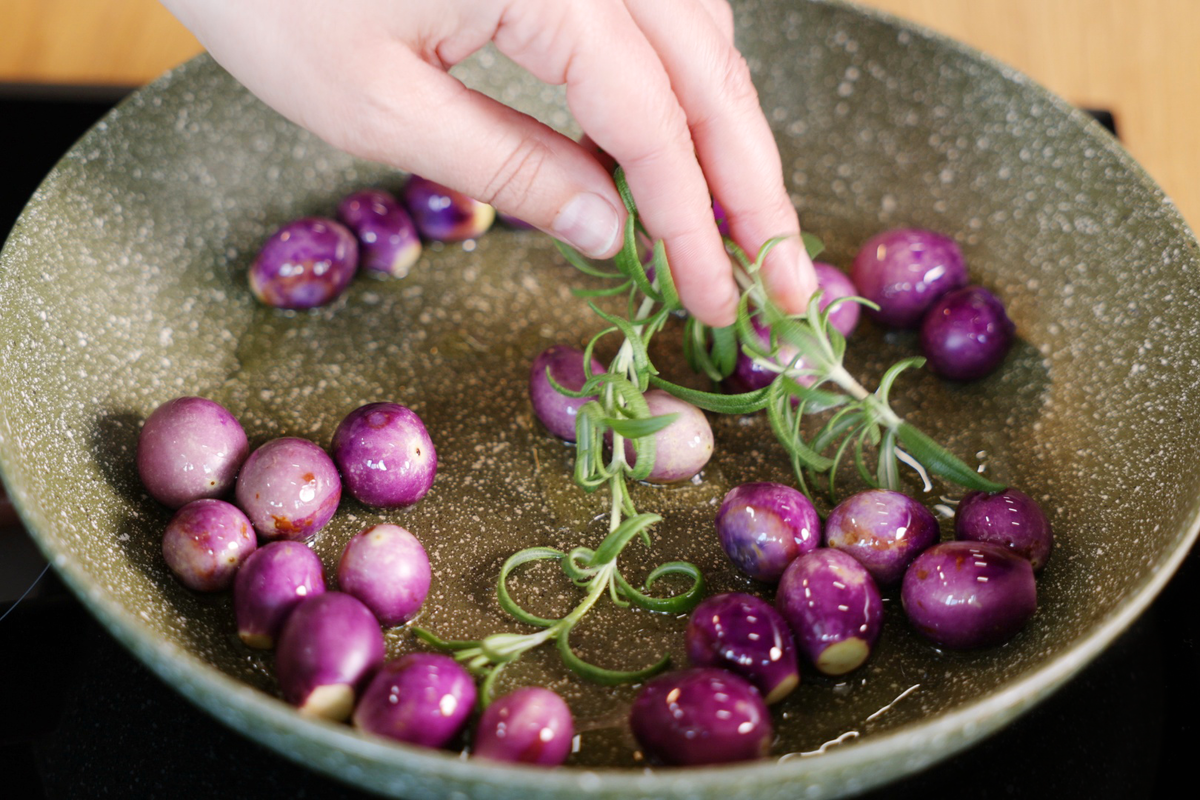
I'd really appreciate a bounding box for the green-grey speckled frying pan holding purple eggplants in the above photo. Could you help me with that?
[0,0,1200,800]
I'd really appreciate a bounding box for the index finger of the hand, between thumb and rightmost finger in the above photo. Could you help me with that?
[496,0,737,325]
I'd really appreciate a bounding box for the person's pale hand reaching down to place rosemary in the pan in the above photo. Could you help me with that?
[163,0,816,325]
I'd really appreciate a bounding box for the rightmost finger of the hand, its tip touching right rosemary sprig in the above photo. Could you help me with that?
[626,0,816,313]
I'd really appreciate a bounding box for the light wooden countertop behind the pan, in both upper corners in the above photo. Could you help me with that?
[0,0,1200,229]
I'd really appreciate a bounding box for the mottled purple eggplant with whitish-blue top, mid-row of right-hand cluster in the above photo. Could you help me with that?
[824,489,941,587]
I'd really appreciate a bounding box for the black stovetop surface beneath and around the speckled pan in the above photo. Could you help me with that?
[0,88,1200,800]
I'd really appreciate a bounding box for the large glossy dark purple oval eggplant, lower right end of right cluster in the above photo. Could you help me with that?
[900,541,1038,650]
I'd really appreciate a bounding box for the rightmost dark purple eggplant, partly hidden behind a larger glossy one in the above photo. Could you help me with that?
[954,488,1054,572]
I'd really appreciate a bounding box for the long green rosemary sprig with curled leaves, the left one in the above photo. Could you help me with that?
[414,170,704,705]
